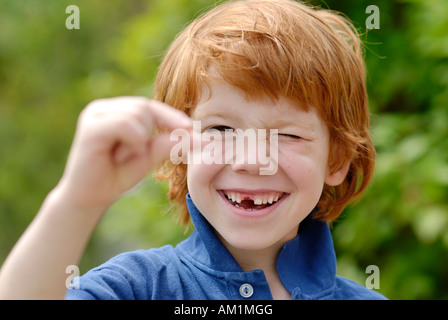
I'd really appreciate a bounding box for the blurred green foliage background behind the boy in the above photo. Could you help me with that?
[0,0,448,299]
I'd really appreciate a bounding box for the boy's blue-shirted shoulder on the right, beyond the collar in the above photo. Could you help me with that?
[334,276,387,300]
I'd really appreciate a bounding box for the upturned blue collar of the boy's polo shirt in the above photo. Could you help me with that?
[186,194,336,297]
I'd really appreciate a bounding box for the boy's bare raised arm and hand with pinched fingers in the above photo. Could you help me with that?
[0,97,191,299]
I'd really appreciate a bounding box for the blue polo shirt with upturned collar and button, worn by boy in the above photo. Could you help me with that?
[66,195,384,300]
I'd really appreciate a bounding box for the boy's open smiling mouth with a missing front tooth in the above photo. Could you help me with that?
[221,190,285,211]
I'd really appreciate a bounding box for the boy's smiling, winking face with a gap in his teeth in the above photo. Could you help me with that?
[187,77,345,250]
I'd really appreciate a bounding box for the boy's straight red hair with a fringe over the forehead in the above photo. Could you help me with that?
[154,0,375,223]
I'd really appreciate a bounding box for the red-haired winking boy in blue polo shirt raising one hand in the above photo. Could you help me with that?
[0,0,383,299]
